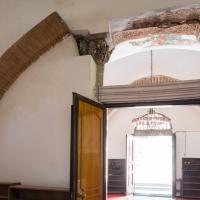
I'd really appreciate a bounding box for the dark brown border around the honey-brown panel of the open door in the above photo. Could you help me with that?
[70,92,107,200]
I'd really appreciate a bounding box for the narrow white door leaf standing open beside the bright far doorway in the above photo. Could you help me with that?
[126,135,134,194]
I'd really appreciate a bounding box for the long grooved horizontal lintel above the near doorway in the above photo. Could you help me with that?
[98,80,200,105]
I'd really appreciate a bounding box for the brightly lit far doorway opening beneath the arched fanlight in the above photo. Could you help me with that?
[133,136,173,197]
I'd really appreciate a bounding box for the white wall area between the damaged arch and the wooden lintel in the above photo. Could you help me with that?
[104,46,200,86]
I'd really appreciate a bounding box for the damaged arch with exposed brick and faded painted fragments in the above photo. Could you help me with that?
[110,4,200,46]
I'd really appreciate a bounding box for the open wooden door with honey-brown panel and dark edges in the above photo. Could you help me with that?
[70,93,106,200]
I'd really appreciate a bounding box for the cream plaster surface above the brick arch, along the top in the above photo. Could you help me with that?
[0,0,200,55]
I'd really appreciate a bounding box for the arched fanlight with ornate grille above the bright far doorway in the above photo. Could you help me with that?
[132,108,172,135]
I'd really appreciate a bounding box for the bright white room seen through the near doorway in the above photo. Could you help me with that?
[107,105,200,200]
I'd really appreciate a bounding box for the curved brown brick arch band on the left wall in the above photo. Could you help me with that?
[0,12,70,99]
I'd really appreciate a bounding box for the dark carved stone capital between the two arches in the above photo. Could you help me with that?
[75,33,111,65]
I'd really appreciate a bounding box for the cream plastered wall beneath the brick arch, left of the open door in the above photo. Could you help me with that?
[0,37,96,187]
